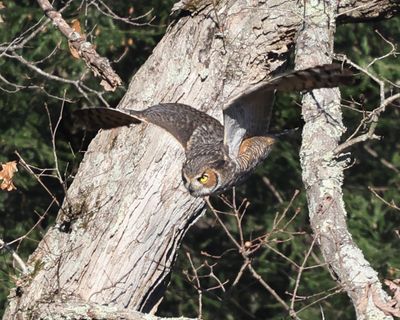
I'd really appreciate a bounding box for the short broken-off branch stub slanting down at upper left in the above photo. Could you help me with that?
[37,0,122,91]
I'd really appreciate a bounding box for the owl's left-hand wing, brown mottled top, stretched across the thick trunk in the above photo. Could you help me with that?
[75,103,223,150]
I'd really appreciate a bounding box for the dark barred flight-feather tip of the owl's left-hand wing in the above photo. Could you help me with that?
[73,108,142,131]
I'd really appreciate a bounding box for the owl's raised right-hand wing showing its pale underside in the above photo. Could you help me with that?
[224,64,353,158]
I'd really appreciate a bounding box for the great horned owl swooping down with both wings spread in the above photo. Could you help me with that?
[76,64,353,197]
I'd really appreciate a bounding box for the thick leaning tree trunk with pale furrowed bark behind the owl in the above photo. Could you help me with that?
[3,0,400,319]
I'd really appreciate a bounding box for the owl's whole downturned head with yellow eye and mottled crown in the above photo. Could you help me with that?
[182,159,226,197]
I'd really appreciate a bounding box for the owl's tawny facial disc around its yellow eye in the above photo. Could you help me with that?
[182,169,219,197]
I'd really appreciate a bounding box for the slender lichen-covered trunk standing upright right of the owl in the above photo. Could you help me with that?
[296,0,392,320]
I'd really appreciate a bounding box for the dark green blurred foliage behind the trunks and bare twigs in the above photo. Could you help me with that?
[0,0,400,319]
